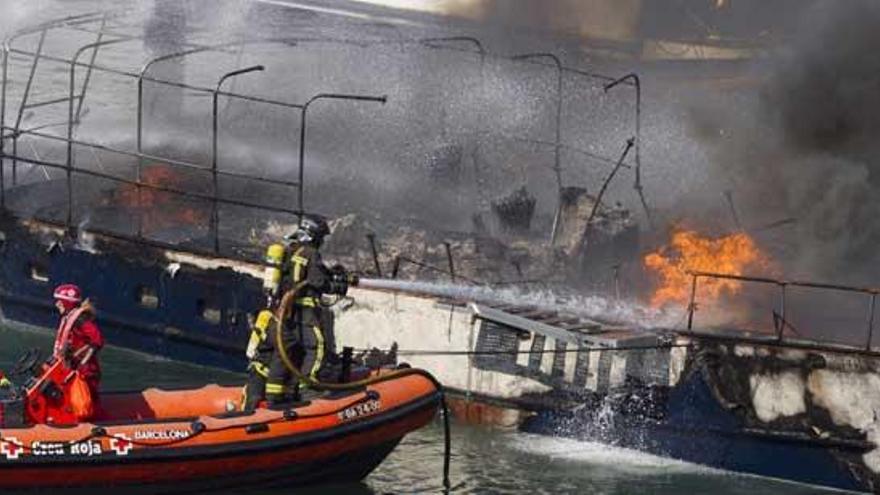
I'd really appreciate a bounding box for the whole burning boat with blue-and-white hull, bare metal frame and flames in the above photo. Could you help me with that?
[0,3,880,491]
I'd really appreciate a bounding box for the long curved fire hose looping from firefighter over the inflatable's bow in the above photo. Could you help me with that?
[274,282,452,492]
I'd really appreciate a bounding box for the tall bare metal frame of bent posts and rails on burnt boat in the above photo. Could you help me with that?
[0,13,640,260]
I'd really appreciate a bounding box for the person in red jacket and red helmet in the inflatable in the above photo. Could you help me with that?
[53,284,104,404]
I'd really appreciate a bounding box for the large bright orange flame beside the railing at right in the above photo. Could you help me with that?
[644,228,771,307]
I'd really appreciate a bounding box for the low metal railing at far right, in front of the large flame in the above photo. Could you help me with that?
[687,272,880,352]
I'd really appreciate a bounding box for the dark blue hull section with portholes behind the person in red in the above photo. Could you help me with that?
[0,217,254,371]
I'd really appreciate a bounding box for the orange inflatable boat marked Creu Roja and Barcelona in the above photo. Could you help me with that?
[0,369,442,495]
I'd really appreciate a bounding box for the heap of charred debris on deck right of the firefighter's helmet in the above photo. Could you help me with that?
[308,184,639,289]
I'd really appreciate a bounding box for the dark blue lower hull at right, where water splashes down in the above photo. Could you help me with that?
[522,373,876,491]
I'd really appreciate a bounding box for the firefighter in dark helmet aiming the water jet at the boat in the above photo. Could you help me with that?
[266,215,357,405]
